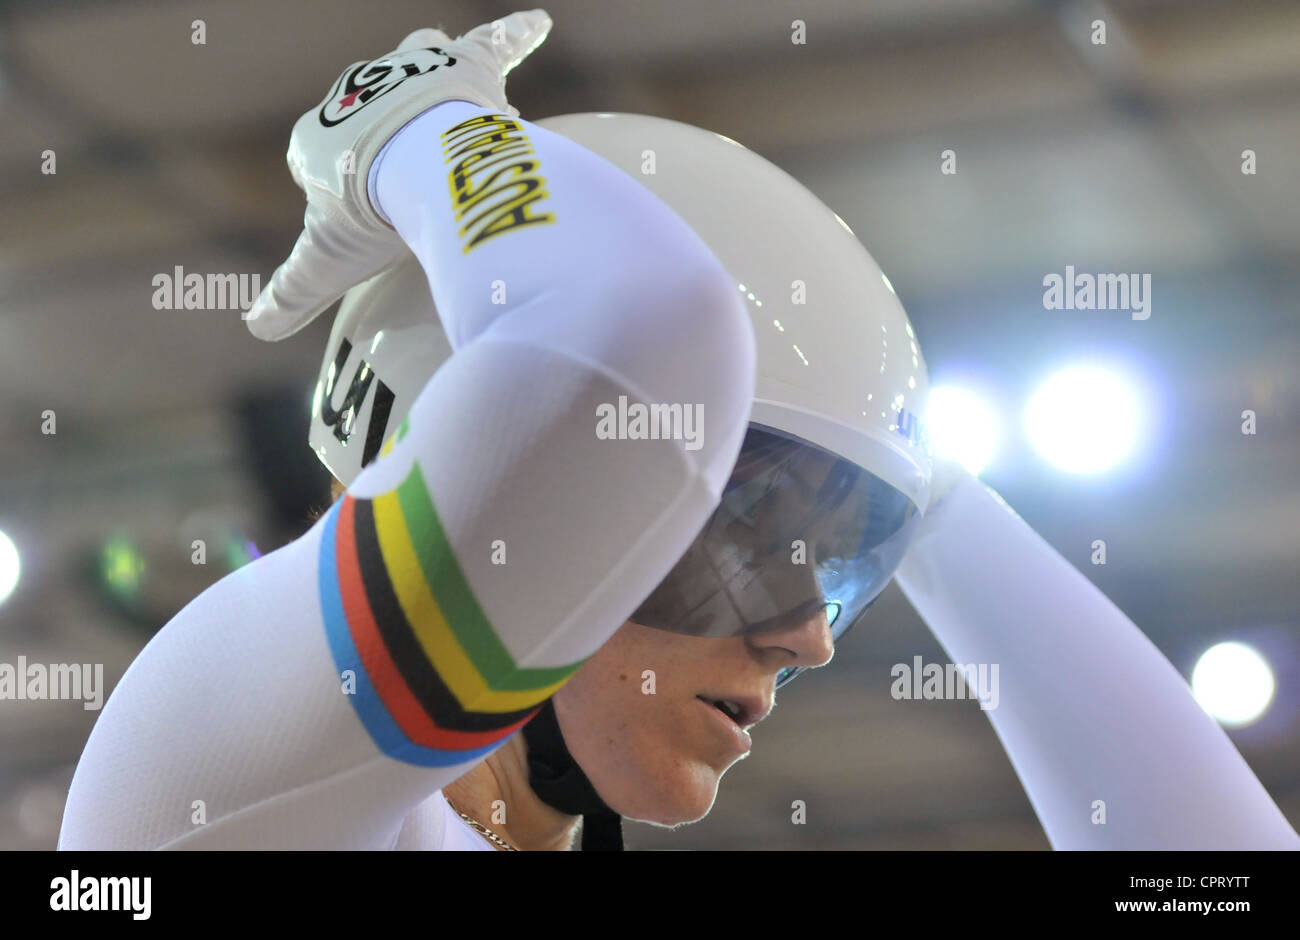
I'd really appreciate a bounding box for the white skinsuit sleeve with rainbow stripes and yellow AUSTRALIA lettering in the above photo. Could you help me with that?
[60,101,754,849]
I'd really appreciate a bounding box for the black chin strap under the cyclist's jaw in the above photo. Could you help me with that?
[524,701,623,852]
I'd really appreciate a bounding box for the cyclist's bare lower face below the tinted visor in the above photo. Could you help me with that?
[554,611,833,826]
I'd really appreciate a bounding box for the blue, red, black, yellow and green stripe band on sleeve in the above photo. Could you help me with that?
[319,460,581,767]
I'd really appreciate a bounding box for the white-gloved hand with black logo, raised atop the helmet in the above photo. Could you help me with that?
[244,9,551,339]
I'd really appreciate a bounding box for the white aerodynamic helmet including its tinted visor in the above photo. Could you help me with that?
[309,113,931,681]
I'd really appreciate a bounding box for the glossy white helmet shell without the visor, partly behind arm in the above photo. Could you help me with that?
[309,113,931,511]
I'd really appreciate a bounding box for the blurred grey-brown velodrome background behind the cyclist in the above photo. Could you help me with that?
[0,0,1300,849]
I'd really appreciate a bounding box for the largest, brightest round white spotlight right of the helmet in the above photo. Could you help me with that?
[1024,365,1141,473]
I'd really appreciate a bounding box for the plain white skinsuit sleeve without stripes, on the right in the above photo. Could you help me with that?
[897,475,1300,850]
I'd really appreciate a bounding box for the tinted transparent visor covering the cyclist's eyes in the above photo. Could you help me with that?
[632,424,920,685]
